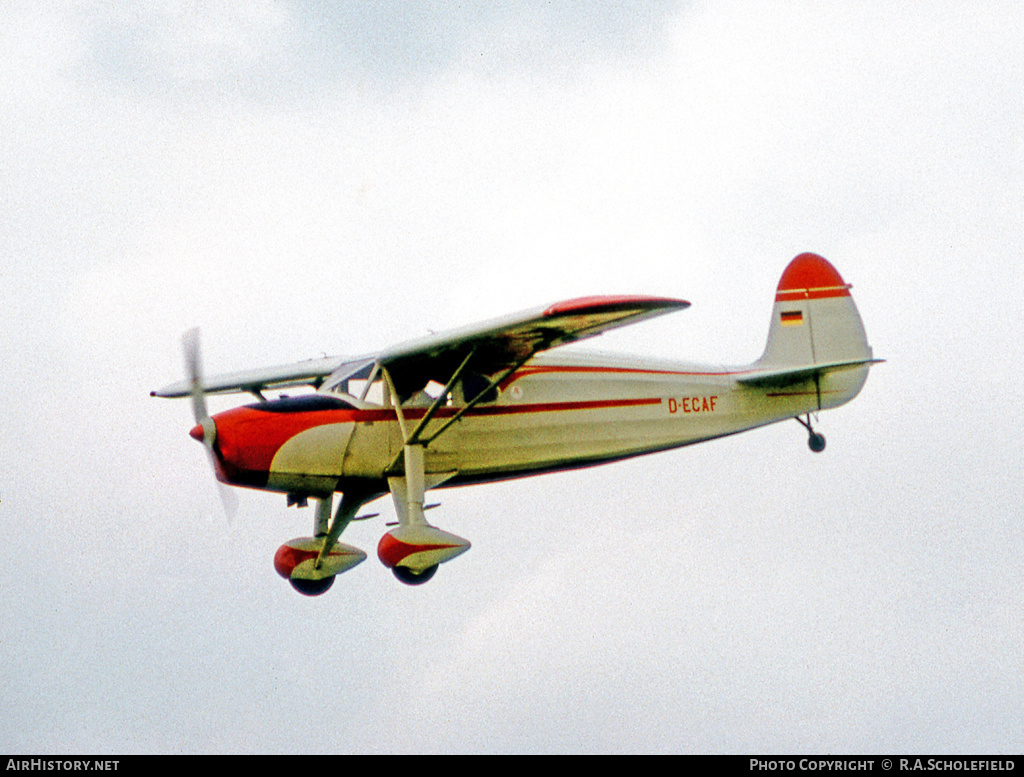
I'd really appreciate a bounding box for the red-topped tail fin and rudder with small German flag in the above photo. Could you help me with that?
[740,254,880,409]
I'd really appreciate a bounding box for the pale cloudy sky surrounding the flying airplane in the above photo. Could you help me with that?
[0,0,1024,753]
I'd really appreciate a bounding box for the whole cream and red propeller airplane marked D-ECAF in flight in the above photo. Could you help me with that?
[151,253,882,596]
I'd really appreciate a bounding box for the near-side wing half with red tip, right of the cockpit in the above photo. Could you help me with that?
[368,296,690,397]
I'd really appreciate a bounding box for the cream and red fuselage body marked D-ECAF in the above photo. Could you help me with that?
[213,350,867,494]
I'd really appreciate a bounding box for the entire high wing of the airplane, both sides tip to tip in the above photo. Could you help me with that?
[151,296,690,399]
